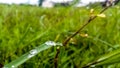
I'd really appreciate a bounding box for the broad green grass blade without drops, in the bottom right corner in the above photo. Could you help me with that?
[86,46,120,67]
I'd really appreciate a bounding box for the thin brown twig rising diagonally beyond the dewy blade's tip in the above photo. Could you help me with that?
[54,5,111,68]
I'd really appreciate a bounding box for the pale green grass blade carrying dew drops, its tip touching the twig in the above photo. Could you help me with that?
[3,41,62,68]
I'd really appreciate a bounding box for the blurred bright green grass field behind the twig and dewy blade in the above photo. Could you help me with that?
[0,5,120,68]
